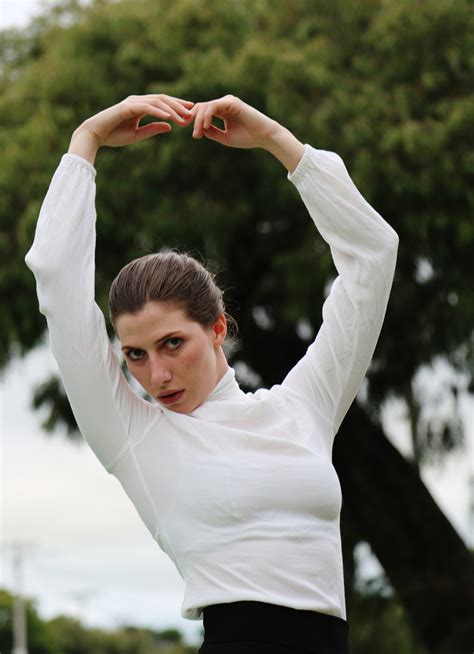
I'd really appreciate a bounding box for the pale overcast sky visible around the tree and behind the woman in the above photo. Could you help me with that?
[0,0,474,640]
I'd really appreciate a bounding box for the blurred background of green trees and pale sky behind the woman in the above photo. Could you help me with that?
[0,0,474,654]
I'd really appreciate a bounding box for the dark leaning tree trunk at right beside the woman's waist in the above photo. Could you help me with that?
[334,403,474,654]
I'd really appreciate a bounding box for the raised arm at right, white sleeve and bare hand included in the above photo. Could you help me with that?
[191,96,398,436]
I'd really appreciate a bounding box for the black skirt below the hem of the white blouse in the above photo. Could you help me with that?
[198,602,349,654]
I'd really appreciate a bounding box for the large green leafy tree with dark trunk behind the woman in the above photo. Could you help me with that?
[0,0,474,654]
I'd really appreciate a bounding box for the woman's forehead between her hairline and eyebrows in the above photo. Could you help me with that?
[115,302,200,344]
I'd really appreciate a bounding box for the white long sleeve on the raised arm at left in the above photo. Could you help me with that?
[25,154,157,471]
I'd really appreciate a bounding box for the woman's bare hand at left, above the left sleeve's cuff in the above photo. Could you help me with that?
[69,94,194,164]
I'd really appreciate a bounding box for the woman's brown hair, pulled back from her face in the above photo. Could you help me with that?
[109,250,236,340]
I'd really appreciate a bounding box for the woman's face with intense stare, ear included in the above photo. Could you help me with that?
[115,302,228,413]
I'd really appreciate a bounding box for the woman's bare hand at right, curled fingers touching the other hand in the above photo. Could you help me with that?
[191,95,282,148]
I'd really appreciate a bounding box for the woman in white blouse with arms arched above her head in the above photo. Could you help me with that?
[26,95,398,654]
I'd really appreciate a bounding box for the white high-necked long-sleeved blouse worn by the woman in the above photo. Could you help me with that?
[26,145,398,619]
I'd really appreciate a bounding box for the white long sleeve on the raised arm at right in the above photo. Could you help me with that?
[283,145,398,436]
